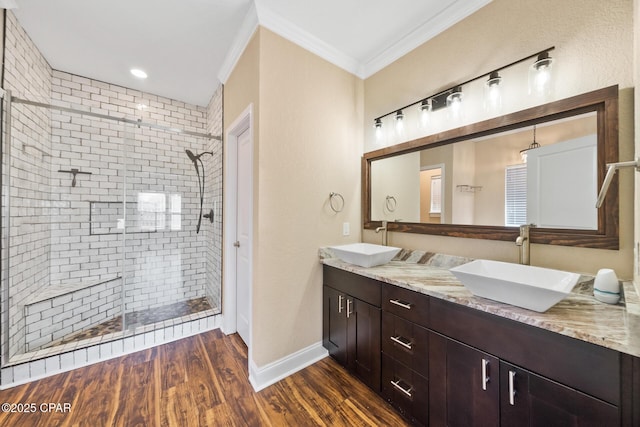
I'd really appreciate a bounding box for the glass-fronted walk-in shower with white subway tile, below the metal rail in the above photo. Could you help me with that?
[2,93,221,366]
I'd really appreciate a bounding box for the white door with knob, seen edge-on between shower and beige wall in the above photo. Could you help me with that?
[235,129,253,345]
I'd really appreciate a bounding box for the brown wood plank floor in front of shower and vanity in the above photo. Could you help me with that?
[0,330,407,427]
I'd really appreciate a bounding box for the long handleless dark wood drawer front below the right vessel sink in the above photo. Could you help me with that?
[429,299,620,405]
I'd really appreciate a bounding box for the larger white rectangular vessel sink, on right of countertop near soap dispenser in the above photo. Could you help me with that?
[450,260,580,312]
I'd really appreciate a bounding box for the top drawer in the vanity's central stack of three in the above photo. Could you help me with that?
[382,284,429,327]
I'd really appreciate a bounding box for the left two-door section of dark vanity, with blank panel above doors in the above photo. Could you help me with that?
[322,266,381,392]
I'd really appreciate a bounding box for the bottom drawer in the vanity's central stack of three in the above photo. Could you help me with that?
[381,354,429,425]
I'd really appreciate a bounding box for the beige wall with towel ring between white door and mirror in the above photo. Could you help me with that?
[224,28,363,367]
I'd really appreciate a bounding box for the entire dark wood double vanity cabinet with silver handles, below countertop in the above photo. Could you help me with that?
[323,265,640,427]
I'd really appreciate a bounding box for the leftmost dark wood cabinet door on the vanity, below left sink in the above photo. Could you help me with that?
[322,286,347,366]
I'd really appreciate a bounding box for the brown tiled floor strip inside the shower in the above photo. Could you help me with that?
[46,297,212,348]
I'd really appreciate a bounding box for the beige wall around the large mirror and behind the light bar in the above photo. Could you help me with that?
[363,0,634,278]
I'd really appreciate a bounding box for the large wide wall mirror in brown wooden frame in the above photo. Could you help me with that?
[362,86,619,249]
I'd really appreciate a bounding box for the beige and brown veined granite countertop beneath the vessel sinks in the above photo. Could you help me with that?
[319,248,640,357]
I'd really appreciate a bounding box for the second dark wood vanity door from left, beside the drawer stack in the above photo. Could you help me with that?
[347,296,381,391]
